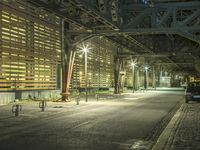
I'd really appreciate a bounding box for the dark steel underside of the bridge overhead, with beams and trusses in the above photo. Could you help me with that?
[29,0,200,73]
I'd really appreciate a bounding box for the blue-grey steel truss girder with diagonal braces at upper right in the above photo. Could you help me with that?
[121,2,200,43]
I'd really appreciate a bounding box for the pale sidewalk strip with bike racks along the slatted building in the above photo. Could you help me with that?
[0,95,123,119]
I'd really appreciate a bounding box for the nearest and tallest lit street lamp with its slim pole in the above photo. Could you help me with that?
[81,45,91,102]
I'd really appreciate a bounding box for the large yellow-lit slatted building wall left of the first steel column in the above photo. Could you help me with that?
[0,0,61,92]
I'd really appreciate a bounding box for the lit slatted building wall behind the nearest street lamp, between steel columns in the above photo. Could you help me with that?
[72,37,117,89]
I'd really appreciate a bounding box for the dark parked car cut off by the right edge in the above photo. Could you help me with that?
[185,82,200,103]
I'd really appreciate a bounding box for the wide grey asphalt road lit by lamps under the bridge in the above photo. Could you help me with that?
[0,91,183,150]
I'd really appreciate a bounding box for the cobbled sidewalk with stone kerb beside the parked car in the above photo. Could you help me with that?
[153,102,200,150]
